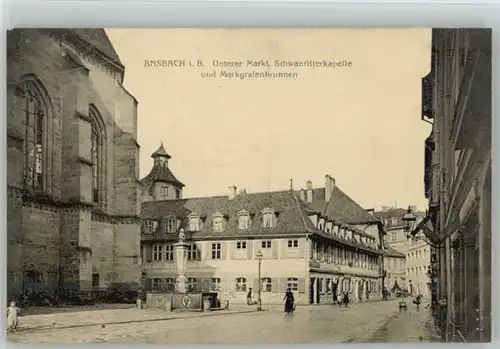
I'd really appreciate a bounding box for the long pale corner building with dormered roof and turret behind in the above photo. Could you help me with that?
[142,147,383,303]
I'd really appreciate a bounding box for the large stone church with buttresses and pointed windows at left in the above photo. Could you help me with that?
[7,29,141,298]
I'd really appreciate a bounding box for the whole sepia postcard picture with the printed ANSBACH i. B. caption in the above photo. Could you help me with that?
[5,28,492,344]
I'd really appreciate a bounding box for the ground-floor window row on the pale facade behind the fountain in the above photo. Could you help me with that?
[146,277,302,292]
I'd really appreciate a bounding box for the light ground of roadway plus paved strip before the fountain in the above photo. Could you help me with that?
[8,300,426,345]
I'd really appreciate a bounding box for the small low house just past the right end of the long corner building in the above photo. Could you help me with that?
[384,245,407,293]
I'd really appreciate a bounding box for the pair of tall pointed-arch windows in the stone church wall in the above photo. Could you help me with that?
[16,80,106,203]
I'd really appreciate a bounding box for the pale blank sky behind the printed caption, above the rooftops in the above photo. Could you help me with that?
[107,29,431,209]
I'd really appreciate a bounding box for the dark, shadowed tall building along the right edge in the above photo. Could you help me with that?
[416,29,492,342]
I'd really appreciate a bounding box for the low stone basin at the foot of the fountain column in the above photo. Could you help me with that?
[146,292,221,311]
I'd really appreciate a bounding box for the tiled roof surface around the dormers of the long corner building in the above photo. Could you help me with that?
[141,190,379,253]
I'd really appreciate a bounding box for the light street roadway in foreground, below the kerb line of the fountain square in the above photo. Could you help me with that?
[9,300,425,344]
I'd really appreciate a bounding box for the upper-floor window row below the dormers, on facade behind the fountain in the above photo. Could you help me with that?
[146,240,299,261]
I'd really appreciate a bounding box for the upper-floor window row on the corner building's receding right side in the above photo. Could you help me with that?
[309,241,379,270]
